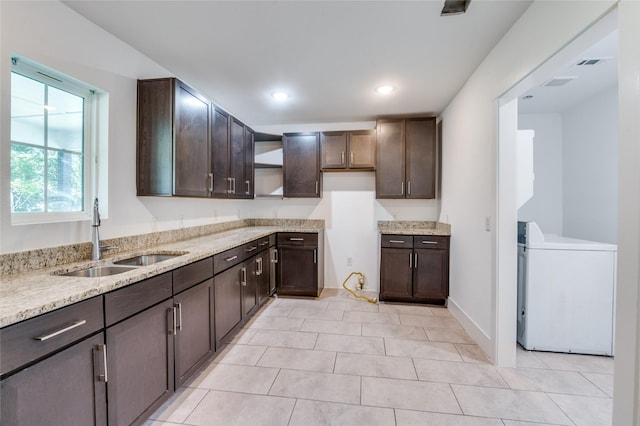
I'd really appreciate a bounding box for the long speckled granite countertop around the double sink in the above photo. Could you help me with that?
[0,221,324,328]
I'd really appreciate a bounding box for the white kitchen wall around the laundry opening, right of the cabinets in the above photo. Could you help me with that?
[441,1,614,362]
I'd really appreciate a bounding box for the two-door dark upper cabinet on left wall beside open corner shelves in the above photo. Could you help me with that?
[211,108,254,198]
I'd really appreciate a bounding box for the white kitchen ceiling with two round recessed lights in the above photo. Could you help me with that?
[64,0,531,126]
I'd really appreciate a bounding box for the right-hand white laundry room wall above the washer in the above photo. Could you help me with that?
[564,87,619,244]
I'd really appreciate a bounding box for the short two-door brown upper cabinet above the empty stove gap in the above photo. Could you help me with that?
[320,130,376,171]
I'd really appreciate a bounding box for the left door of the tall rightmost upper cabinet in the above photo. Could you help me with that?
[376,120,405,198]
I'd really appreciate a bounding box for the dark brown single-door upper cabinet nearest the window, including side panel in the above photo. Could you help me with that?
[136,78,211,197]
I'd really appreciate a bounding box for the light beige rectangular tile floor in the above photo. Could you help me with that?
[145,289,613,426]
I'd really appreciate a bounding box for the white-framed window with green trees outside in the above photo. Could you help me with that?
[10,58,96,223]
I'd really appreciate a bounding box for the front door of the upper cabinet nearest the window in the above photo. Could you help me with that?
[173,81,210,197]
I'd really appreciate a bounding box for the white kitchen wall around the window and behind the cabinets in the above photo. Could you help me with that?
[0,1,439,290]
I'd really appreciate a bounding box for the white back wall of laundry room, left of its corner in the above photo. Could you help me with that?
[518,113,562,235]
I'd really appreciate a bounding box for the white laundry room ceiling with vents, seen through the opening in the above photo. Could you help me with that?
[518,31,618,114]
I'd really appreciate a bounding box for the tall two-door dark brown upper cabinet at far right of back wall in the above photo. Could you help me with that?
[376,117,436,199]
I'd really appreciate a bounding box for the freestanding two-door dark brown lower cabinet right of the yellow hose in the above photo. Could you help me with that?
[380,235,449,304]
